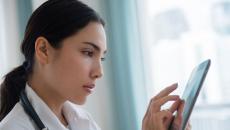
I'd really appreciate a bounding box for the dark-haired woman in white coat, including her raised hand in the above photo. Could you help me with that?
[0,0,190,130]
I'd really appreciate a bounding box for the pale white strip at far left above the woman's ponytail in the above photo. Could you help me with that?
[0,0,22,77]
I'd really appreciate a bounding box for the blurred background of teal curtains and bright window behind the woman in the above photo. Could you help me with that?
[0,0,230,130]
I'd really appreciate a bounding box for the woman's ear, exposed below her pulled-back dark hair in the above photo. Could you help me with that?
[35,37,51,65]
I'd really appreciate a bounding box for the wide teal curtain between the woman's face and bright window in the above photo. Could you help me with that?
[105,0,147,130]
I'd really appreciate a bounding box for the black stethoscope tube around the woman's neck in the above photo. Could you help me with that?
[20,90,48,130]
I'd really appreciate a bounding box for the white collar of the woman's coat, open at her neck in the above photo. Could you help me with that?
[25,84,100,130]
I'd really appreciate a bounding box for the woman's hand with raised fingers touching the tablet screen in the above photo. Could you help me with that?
[142,84,181,130]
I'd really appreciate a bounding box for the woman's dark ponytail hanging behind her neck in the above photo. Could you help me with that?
[0,65,27,121]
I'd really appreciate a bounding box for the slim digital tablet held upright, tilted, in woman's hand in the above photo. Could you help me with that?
[170,59,211,130]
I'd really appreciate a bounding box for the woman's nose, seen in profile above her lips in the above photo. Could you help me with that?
[91,62,103,79]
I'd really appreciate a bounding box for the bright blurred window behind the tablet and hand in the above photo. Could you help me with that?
[138,0,230,130]
